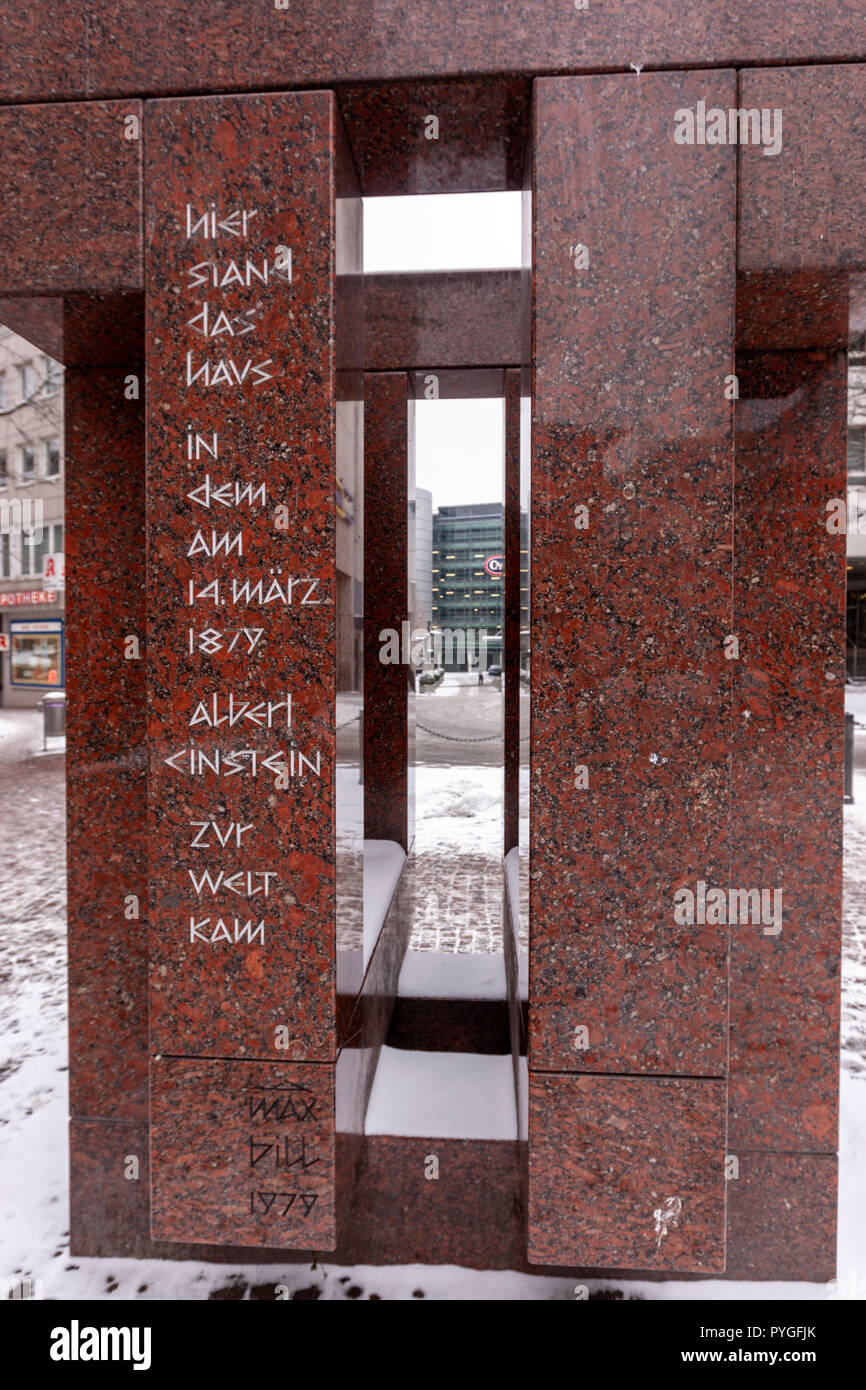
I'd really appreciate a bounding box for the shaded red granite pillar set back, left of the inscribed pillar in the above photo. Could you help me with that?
[61,299,147,1254]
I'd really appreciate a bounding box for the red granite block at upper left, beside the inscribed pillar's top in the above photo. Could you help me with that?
[0,100,143,295]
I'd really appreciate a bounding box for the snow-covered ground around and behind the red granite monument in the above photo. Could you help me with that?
[0,706,866,1301]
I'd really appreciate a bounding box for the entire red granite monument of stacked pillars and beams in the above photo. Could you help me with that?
[0,0,866,1280]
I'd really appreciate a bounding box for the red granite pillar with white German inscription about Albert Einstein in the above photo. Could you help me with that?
[145,92,361,1250]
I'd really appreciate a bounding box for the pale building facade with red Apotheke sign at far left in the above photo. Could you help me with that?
[0,325,65,709]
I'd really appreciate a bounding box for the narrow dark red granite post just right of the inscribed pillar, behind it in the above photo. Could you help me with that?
[364,373,416,851]
